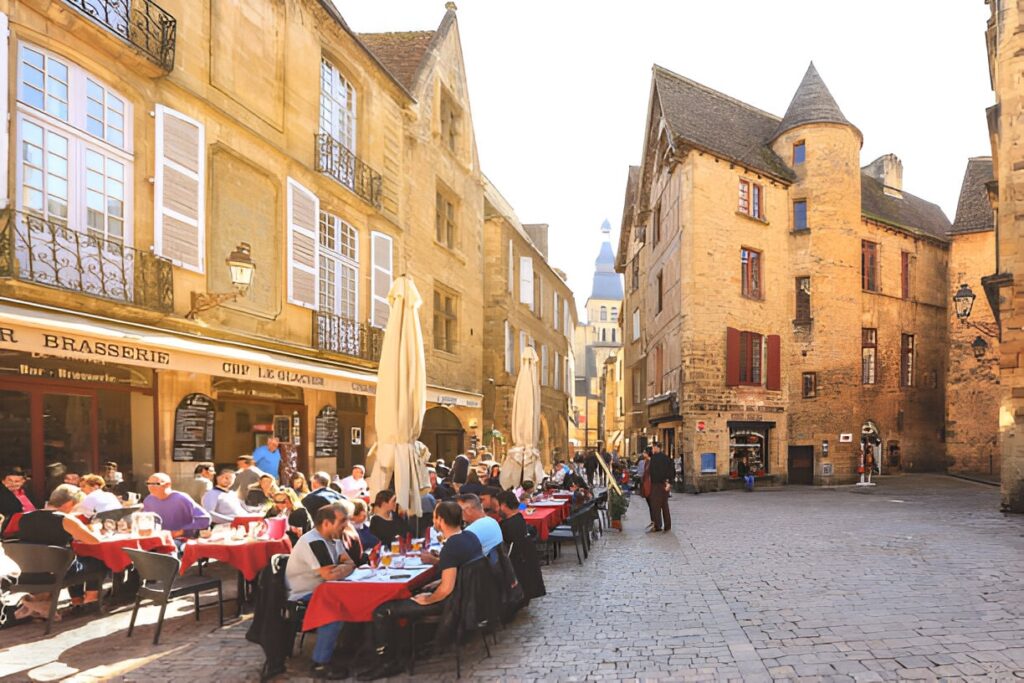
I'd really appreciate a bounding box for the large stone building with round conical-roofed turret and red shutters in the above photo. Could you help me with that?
[620,65,949,489]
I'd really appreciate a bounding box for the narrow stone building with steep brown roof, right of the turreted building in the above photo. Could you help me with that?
[946,157,1000,477]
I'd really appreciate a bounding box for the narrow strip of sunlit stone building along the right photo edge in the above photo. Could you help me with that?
[976,0,1024,512]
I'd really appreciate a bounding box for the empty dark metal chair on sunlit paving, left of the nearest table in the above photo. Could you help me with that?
[124,548,224,645]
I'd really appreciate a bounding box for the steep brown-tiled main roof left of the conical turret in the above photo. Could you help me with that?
[654,65,796,181]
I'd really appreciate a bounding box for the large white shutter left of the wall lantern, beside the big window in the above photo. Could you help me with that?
[154,104,206,272]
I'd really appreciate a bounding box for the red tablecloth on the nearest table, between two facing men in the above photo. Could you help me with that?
[302,567,437,631]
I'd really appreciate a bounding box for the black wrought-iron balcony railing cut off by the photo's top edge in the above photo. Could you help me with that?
[63,0,177,72]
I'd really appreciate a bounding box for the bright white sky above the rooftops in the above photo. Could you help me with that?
[335,0,993,317]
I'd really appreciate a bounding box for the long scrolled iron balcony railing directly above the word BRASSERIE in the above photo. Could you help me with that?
[0,211,174,313]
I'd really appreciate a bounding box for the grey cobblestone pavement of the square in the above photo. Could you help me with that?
[0,475,1024,683]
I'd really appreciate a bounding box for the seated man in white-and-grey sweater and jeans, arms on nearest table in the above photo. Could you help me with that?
[285,505,355,680]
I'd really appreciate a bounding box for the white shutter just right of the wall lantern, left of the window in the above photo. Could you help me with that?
[288,178,319,308]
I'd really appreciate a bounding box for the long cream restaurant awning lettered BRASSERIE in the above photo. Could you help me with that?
[0,303,481,408]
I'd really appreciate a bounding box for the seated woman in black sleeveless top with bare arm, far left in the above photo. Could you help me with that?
[15,483,104,618]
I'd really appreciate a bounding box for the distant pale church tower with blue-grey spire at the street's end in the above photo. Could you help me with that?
[571,220,623,449]
